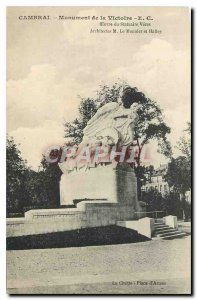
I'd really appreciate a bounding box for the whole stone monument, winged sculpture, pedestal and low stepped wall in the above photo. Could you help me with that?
[7,88,143,236]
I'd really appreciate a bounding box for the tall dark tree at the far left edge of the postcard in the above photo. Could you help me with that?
[6,136,28,215]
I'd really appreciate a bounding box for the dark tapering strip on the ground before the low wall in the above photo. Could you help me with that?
[7,225,150,250]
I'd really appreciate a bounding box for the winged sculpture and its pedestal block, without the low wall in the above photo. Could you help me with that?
[59,87,142,218]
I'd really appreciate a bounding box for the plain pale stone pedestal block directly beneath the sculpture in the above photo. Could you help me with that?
[60,163,137,209]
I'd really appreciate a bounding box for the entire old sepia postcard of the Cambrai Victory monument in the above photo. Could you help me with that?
[6,6,191,295]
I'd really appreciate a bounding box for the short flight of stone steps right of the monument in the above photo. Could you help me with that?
[153,219,186,240]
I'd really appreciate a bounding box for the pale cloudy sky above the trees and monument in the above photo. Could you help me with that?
[7,7,191,170]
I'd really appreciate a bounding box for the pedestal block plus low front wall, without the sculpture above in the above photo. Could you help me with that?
[7,163,141,236]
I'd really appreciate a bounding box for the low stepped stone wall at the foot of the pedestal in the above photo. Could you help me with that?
[7,201,137,237]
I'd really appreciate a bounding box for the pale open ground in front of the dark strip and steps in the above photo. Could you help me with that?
[7,236,191,294]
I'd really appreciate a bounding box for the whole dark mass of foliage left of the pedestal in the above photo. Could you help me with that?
[7,137,62,216]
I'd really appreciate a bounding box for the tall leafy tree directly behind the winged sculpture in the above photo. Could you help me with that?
[65,82,171,195]
